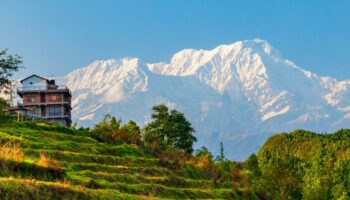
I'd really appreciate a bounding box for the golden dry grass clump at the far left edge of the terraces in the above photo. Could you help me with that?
[0,141,24,162]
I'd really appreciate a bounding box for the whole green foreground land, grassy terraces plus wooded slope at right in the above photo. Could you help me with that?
[0,119,350,199]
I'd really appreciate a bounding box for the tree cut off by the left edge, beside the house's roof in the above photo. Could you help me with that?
[0,50,23,97]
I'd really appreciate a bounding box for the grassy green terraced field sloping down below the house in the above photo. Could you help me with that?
[0,123,235,199]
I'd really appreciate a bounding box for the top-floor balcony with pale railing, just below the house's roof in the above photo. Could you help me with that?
[17,85,71,96]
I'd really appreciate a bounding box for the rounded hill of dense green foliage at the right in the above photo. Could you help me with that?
[252,129,350,199]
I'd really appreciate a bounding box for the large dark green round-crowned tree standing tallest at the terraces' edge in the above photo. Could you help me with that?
[144,105,197,154]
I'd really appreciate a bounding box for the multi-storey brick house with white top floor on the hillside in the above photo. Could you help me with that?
[17,74,72,127]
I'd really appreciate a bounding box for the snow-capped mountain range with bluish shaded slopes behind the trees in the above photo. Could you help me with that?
[59,39,350,160]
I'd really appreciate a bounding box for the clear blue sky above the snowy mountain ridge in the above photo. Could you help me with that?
[0,0,350,80]
